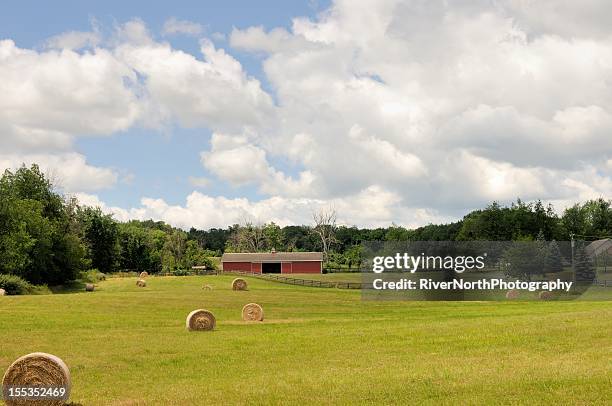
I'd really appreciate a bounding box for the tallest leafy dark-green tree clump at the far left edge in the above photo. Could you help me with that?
[0,165,85,285]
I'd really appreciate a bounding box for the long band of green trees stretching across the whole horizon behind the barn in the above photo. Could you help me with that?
[0,165,612,285]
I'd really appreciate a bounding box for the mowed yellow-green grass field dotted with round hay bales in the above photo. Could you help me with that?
[0,276,612,405]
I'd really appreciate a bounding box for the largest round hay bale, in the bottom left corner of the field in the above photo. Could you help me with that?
[2,352,70,406]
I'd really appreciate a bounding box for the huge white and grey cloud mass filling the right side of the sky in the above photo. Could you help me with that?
[222,0,612,219]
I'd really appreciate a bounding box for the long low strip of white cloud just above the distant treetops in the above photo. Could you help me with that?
[81,188,449,230]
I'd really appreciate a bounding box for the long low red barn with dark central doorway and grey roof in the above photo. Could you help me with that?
[221,252,323,274]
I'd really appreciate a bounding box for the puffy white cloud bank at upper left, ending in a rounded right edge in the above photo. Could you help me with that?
[0,19,272,195]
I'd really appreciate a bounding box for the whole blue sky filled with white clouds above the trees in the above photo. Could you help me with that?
[0,0,612,229]
